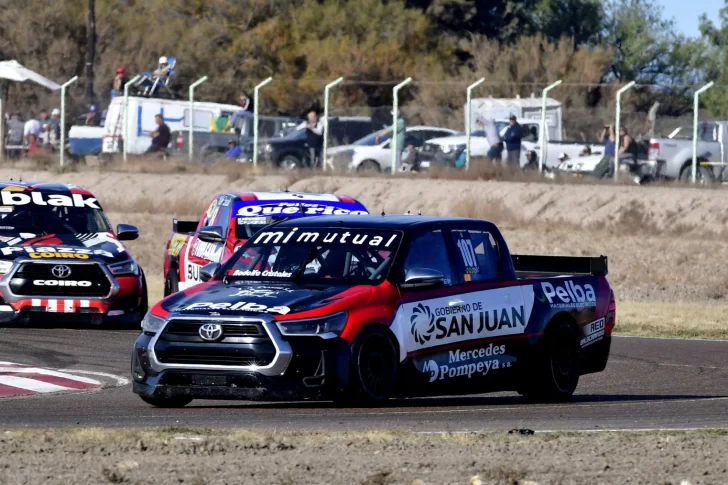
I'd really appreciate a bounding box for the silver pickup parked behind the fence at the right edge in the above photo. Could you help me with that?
[649,121,728,183]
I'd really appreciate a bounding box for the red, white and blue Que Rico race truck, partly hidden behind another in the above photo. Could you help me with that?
[164,192,368,296]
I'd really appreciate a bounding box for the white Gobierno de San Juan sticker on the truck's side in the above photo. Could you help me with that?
[402,286,533,352]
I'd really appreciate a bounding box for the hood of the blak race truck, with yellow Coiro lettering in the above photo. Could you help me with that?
[0,232,130,263]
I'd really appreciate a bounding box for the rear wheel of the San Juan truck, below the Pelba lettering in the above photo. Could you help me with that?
[521,322,581,402]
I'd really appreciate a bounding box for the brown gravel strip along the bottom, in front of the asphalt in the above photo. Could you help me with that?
[0,429,728,485]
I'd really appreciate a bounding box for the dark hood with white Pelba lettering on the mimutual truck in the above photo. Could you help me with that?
[160,281,352,316]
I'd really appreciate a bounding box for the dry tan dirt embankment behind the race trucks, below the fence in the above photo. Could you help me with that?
[0,169,728,303]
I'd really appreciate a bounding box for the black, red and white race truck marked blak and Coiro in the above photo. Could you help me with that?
[0,181,148,325]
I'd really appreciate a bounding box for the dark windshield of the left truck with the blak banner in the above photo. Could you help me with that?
[0,197,111,235]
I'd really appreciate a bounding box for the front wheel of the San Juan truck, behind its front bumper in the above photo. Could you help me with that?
[344,326,399,405]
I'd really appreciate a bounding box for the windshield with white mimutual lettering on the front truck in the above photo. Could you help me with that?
[222,227,402,285]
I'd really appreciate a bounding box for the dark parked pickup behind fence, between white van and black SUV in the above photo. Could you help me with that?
[170,112,302,160]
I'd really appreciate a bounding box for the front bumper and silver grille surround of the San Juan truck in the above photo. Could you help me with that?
[131,317,350,401]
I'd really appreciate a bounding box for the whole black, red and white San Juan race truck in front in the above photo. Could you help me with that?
[132,215,615,407]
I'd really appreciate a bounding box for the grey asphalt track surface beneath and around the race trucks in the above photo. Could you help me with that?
[0,327,728,432]
